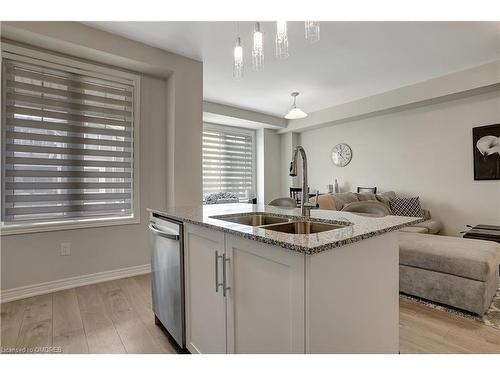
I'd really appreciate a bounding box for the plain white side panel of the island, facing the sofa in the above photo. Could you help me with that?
[306,232,399,354]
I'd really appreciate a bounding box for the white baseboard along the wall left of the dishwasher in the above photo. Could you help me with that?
[0,264,151,302]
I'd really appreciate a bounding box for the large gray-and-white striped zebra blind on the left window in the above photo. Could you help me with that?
[2,59,134,224]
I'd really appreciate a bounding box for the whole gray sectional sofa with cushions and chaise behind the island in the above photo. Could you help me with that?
[312,192,500,315]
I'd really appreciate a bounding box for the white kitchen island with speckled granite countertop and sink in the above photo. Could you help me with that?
[150,204,422,353]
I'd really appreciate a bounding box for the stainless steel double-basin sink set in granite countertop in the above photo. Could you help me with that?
[211,213,348,234]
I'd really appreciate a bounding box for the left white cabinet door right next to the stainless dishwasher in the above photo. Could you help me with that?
[184,225,226,354]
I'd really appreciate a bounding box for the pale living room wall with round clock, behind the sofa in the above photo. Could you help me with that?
[298,91,500,235]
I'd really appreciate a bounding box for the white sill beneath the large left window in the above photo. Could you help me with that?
[0,216,141,236]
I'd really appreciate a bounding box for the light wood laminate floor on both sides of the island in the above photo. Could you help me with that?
[0,275,500,353]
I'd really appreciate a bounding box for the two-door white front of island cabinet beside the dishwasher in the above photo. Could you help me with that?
[184,225,305,353]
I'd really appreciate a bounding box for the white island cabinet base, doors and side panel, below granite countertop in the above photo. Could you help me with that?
[184,224,399,353]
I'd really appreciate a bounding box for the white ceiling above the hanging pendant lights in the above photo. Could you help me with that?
[86,22,500,117]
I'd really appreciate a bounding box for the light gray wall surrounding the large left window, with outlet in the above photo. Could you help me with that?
[0,22,203,291]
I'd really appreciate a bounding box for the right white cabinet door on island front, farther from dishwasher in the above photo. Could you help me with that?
[225,234,305,353]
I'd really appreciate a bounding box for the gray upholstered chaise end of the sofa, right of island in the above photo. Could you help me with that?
[399,232,500,315]
